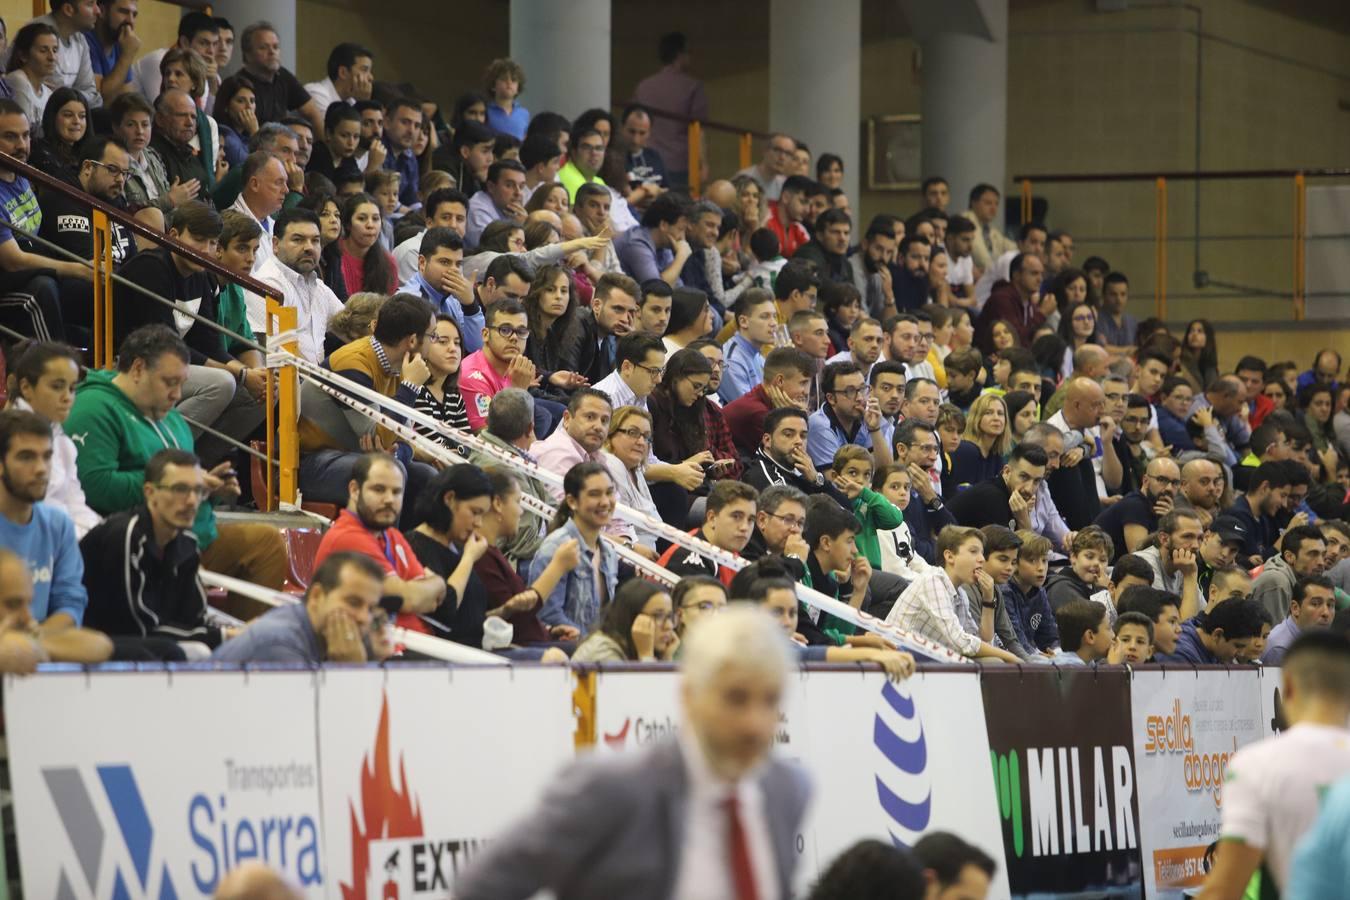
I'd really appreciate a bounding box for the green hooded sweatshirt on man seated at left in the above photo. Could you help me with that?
[65,370,216,549]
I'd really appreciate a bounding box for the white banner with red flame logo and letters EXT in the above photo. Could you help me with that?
[319,667,576,900]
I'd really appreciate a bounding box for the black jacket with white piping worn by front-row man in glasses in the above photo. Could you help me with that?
[80,506,221,648]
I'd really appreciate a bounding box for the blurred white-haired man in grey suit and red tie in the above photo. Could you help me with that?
[454,604,810,900]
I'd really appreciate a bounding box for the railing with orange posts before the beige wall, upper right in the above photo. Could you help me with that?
[1013,169,1350,321]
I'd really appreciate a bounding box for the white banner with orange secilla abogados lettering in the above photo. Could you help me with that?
[1130,669,1269,900]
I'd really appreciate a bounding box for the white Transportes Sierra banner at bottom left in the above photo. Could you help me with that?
[4,672,332,900]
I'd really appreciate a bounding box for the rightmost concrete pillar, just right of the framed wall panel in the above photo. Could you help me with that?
[900,0,1008,223]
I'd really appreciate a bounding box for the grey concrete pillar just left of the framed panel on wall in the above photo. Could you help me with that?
[755,0,863,203]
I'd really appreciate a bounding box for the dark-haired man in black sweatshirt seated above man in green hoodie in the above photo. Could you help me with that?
[112,200,266,466]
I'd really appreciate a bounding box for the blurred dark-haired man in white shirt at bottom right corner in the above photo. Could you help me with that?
[1200,631,1350,900]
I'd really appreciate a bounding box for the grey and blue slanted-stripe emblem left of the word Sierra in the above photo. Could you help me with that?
[42,765,178,900]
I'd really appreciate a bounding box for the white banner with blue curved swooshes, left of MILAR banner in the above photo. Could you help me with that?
[797,672,1008,899]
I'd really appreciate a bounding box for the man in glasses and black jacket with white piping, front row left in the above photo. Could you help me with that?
[80,449,228,656]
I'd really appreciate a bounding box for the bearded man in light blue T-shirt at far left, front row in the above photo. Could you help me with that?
[0,409,112,663]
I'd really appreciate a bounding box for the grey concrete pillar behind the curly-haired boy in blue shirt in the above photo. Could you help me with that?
[510,0,610,119]
